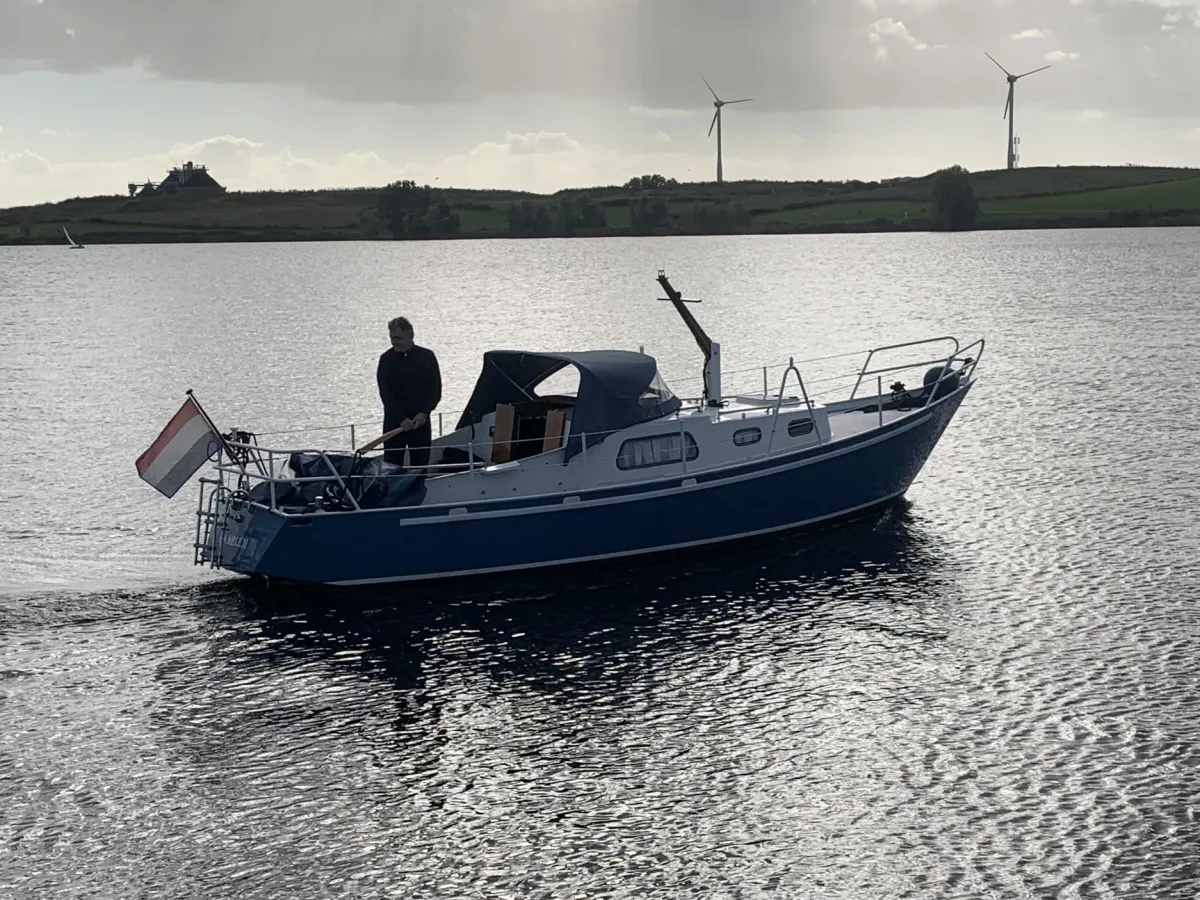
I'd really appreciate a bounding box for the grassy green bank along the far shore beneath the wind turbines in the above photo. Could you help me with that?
[0,166,1200,244]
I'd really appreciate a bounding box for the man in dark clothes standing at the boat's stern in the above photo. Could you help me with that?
[376,316,442,469]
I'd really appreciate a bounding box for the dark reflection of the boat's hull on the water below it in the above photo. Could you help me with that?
[218,502,937,700]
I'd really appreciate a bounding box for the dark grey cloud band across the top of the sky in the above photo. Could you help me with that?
[0,0,1200,115]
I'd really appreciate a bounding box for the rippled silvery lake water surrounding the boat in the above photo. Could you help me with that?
[0,229,1200,900]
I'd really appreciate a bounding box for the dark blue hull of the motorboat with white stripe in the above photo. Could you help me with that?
[213,384,970,584]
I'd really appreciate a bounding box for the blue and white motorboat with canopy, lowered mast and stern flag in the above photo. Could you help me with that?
[138,272,984,584]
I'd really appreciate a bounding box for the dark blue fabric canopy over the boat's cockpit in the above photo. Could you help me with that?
[456,350,682,460]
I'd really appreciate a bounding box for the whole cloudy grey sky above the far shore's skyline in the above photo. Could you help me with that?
[0,0,1200,205]
